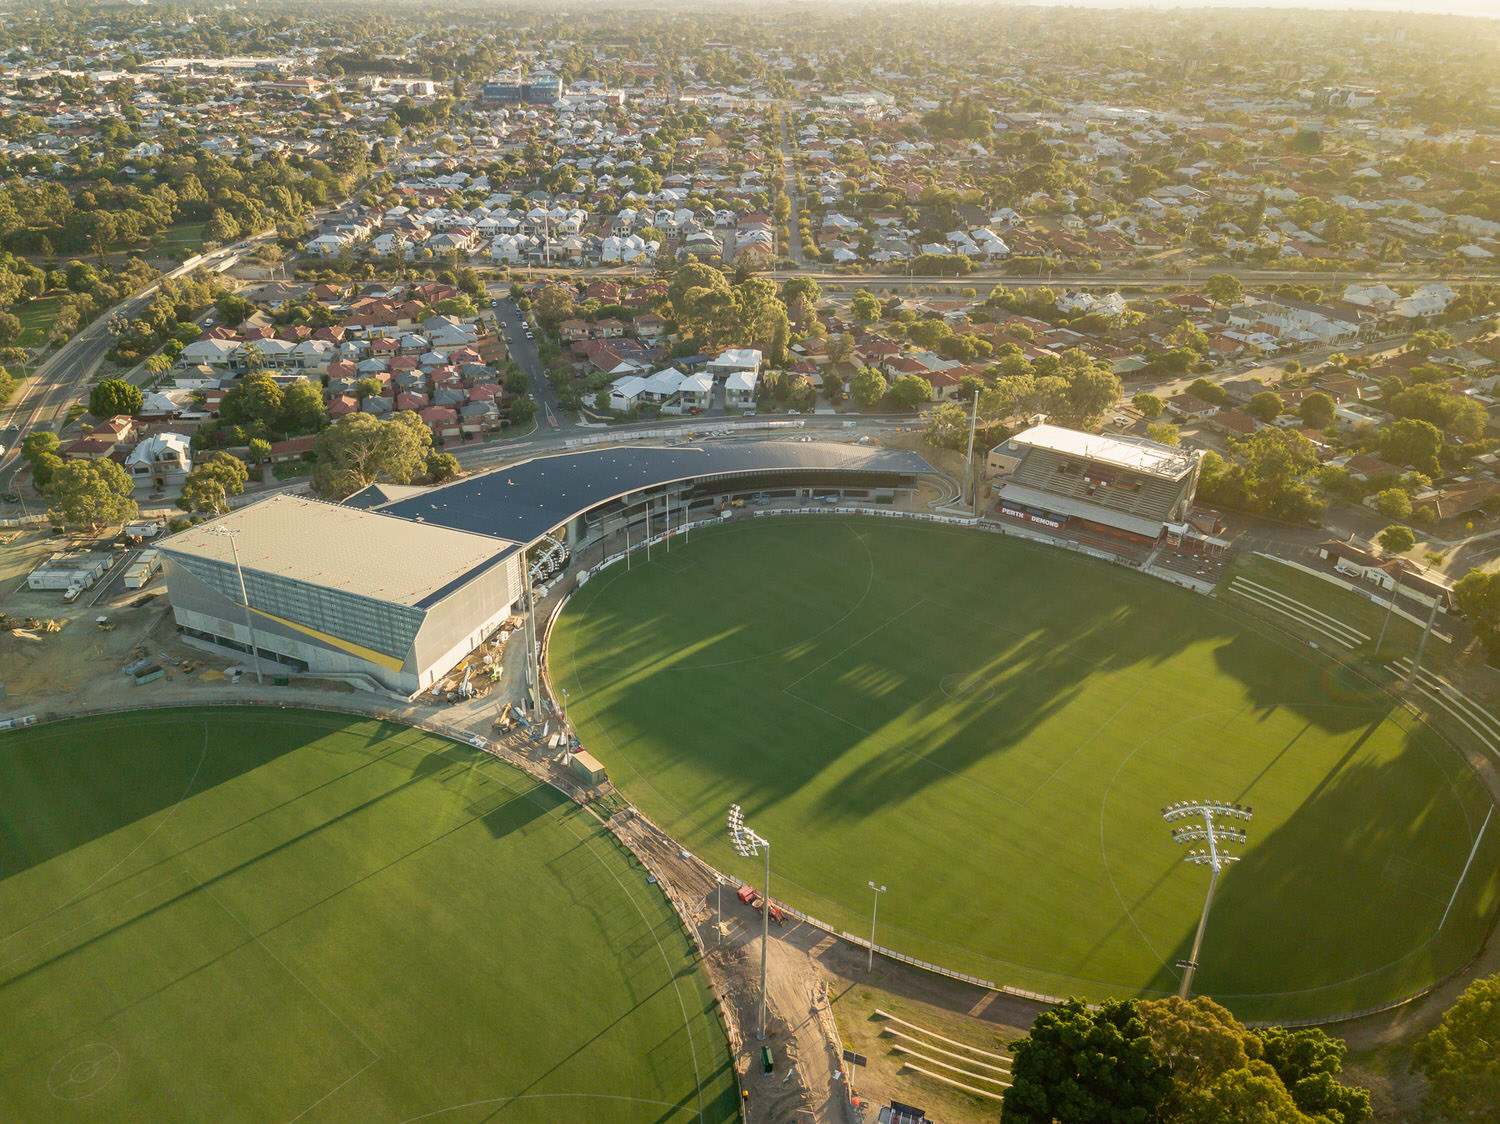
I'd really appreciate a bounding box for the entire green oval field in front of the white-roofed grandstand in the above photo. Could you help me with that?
[551,516,1500,1019]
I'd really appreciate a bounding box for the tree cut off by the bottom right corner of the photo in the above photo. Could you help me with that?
[1413,972,1500,1121]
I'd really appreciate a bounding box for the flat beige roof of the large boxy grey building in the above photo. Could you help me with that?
[161,495,515,606]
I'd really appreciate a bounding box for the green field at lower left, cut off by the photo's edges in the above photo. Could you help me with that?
[0,708,738,1124]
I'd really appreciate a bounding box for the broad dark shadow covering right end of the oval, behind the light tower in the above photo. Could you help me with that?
[1151,731,1500,1017]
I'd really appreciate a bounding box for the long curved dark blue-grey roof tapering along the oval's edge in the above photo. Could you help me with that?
[375,441,933,543]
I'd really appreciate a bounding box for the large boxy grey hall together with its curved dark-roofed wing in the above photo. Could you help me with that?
[159,441,932,696]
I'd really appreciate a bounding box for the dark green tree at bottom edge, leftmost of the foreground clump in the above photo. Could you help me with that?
[1001,999,1172,1124]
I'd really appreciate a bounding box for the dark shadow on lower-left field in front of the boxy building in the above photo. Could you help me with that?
[0,710,410,881]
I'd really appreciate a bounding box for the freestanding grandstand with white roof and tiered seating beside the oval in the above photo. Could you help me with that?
[987,425,1199,545]
